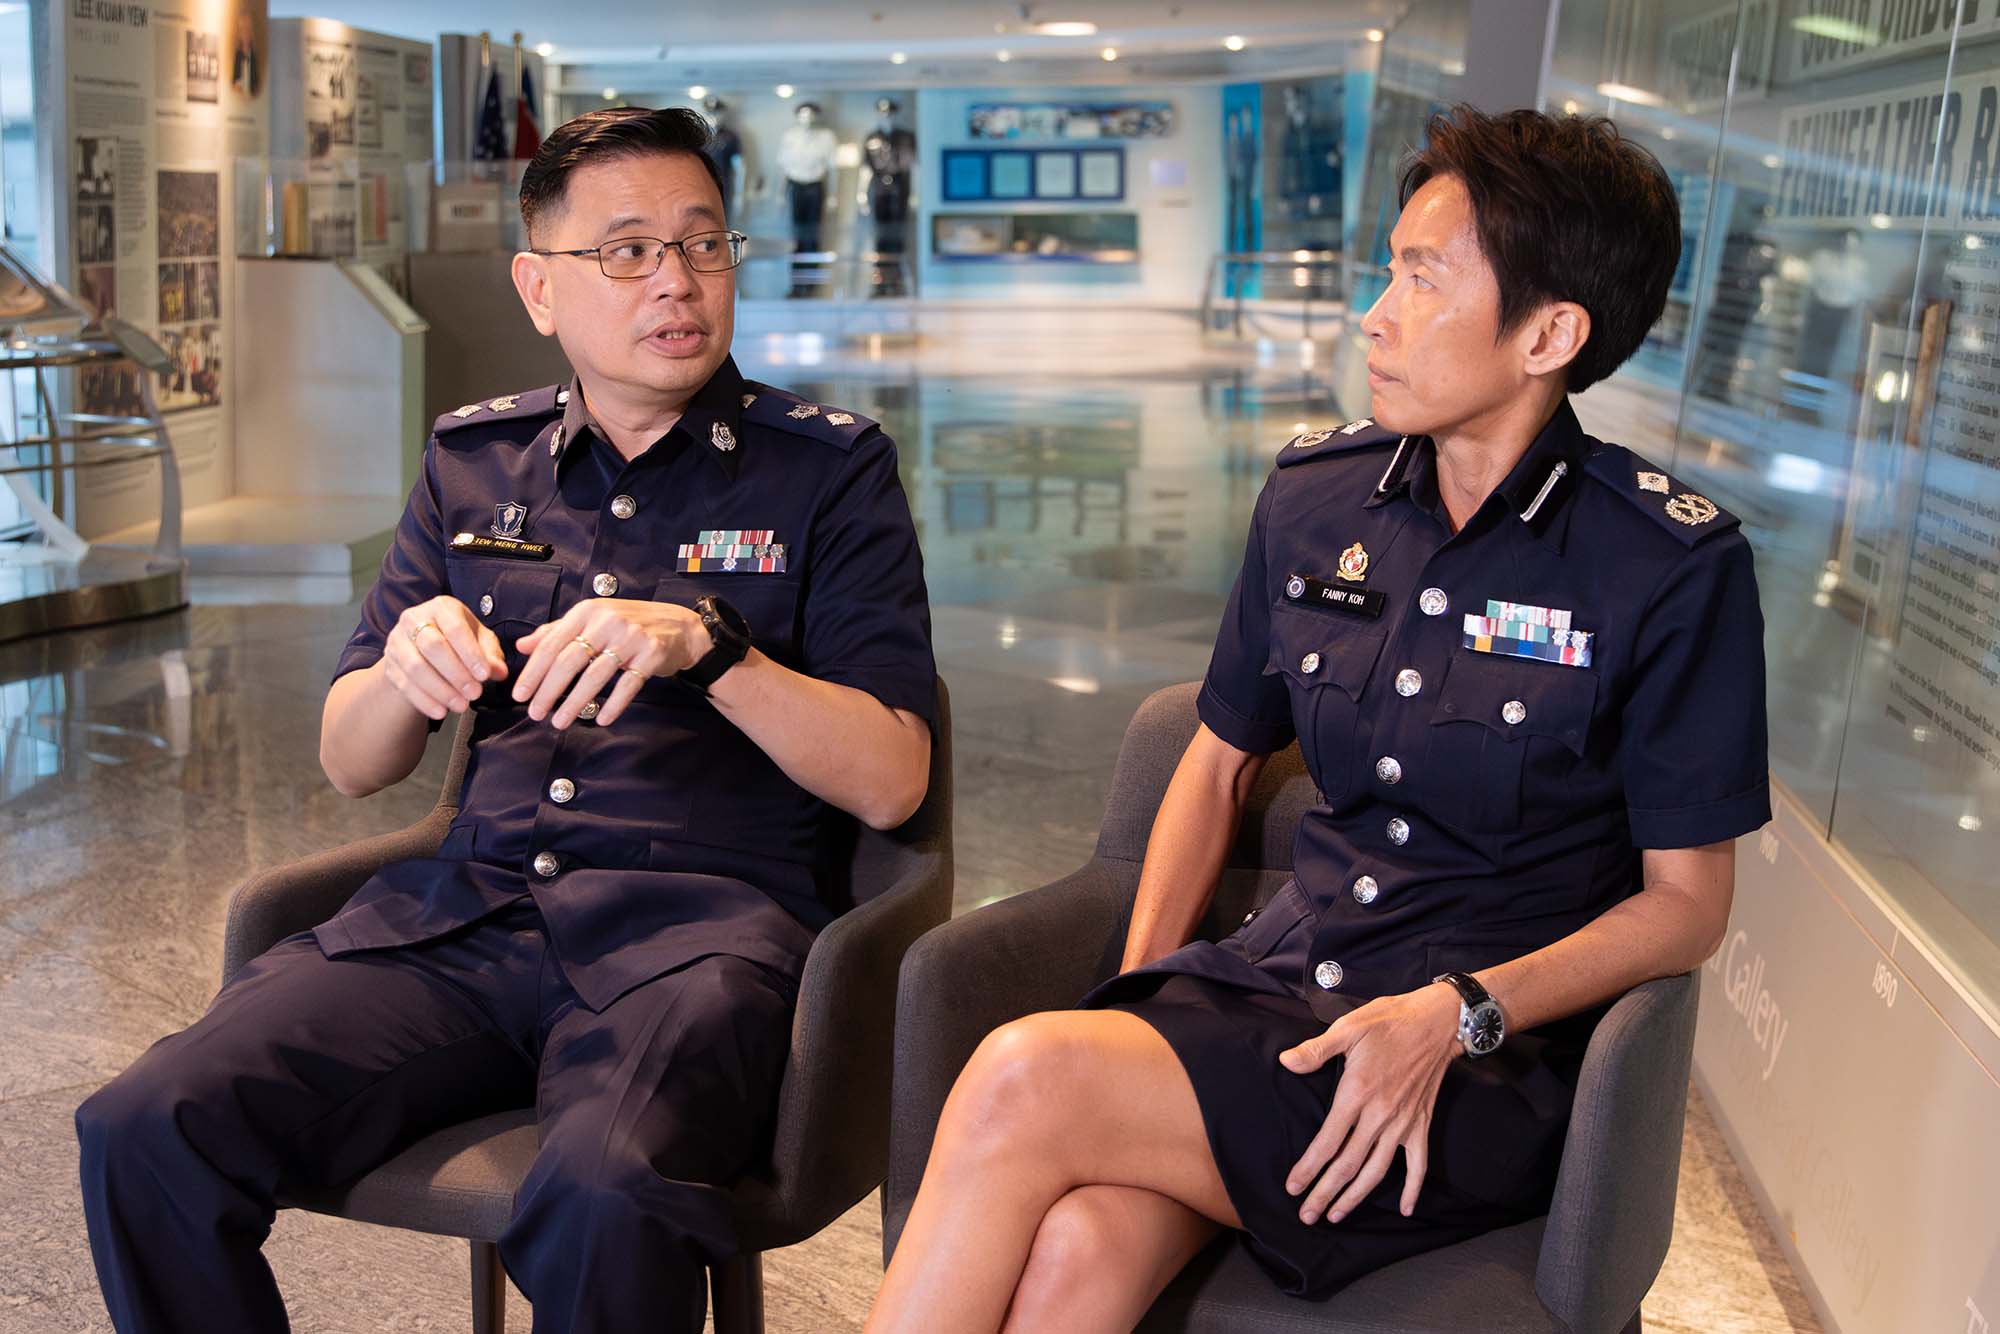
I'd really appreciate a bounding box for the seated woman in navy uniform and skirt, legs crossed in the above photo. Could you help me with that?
[868,108,1770,1334]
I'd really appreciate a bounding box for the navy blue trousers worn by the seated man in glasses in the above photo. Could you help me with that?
[76,898,796,1334]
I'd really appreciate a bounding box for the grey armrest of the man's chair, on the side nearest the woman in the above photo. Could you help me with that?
[732,840,952,1250]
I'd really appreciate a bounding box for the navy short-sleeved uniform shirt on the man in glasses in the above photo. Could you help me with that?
[318,360,936,1010]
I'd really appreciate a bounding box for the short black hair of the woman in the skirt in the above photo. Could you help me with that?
[1400,106,1680,394]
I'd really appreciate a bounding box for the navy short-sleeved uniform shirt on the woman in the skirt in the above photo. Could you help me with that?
[1160,402,1770,1012]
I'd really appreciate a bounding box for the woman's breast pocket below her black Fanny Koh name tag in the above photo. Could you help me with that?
[1264,602,1388,802]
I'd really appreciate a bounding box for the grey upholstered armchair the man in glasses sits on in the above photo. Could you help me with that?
[222,680,952,1334]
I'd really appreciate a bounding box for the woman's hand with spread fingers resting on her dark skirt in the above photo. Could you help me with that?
[1278,982,1464,1222]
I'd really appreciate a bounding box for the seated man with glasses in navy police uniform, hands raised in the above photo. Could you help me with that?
[76,108,936,1334]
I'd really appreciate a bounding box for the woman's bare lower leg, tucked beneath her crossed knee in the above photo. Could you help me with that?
[1002,1186,1218,1334]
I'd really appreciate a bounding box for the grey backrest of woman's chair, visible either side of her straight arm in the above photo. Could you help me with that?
[1096,682,1320,938]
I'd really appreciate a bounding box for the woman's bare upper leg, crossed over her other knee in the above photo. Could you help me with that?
[868,1010,1236,1334]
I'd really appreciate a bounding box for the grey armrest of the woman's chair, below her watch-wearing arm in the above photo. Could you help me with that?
[1534,972,1700,1330]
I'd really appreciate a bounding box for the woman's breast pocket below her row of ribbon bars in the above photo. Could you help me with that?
[1426,648,1598,834]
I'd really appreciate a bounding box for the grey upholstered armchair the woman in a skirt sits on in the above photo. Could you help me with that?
[882,684,1696,1334]
